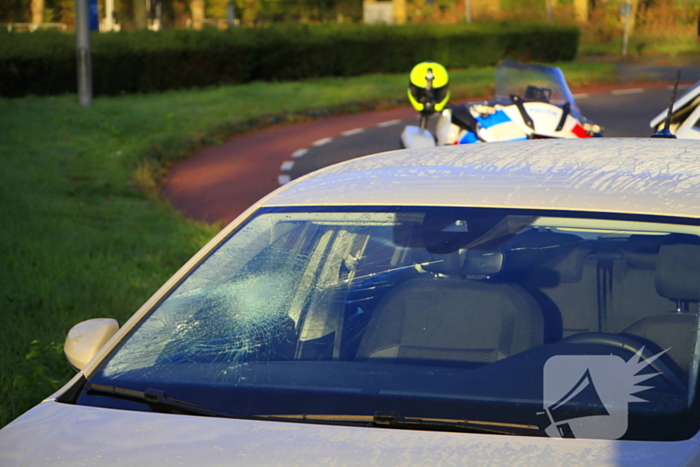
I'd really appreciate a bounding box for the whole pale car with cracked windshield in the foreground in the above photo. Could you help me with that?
[0,139,700,467]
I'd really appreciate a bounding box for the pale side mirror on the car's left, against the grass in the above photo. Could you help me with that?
[63,318,119,371]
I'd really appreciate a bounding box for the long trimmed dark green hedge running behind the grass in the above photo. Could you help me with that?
[0,24,579,97]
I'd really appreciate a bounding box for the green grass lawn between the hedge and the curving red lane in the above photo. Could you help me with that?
[0,63,613,427]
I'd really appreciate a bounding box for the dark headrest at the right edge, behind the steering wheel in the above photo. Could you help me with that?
[655,244,700,301]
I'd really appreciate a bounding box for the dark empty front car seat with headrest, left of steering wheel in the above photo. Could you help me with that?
[358,250,544,365]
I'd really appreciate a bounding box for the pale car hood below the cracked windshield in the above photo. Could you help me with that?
[0,401,700,467]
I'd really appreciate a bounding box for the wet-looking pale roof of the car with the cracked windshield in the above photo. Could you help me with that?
[262,138,700,218]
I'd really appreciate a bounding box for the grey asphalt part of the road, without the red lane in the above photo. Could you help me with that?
[290,86,687,181]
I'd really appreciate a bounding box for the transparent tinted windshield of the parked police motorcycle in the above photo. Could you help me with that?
[493,60,581,119]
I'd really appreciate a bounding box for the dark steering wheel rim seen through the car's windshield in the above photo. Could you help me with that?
[558,332,686,391]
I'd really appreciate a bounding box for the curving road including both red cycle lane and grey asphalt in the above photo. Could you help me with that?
[163,72,700,223]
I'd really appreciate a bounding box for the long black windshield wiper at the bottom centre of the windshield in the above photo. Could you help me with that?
[255,411,542,436]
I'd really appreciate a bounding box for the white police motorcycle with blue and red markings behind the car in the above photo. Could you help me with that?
[401,60,603,148]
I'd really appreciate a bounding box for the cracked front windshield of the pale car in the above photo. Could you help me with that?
[78,207,700,440]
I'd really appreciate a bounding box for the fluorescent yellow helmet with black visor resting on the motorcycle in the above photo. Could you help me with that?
[408,62,450,114]
